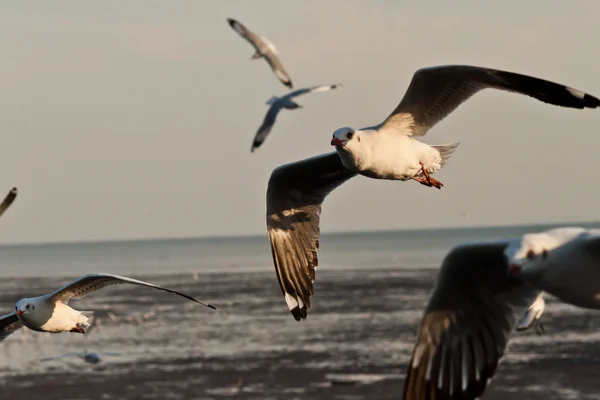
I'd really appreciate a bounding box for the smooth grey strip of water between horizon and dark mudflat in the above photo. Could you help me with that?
[0,223,598,277]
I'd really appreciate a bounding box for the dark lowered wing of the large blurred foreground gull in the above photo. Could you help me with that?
[403,242,540,400]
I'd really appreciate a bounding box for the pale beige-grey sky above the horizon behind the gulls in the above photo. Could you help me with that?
[0,0,600,243]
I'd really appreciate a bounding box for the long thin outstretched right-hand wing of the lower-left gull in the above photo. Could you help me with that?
[48,273,216,310]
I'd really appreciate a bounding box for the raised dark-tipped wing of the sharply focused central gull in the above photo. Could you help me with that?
[381,65,600,136]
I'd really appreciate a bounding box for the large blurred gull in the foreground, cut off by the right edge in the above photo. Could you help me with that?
[403,228,600,400]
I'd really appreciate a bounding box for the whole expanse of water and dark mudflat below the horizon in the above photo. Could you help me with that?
[0,223,600,400]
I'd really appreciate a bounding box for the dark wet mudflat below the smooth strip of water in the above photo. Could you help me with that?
[0,269,600,400]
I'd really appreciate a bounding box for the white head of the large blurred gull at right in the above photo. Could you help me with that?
[504,228,584,277]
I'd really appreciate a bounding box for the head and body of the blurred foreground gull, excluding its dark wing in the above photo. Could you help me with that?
[505,227,600,310]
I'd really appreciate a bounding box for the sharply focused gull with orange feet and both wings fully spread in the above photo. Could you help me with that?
[267,65,600,321]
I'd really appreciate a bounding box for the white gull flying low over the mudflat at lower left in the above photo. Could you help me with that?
[0,273,216,341]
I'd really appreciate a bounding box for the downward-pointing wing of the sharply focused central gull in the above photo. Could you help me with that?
[267,153,356,321]
